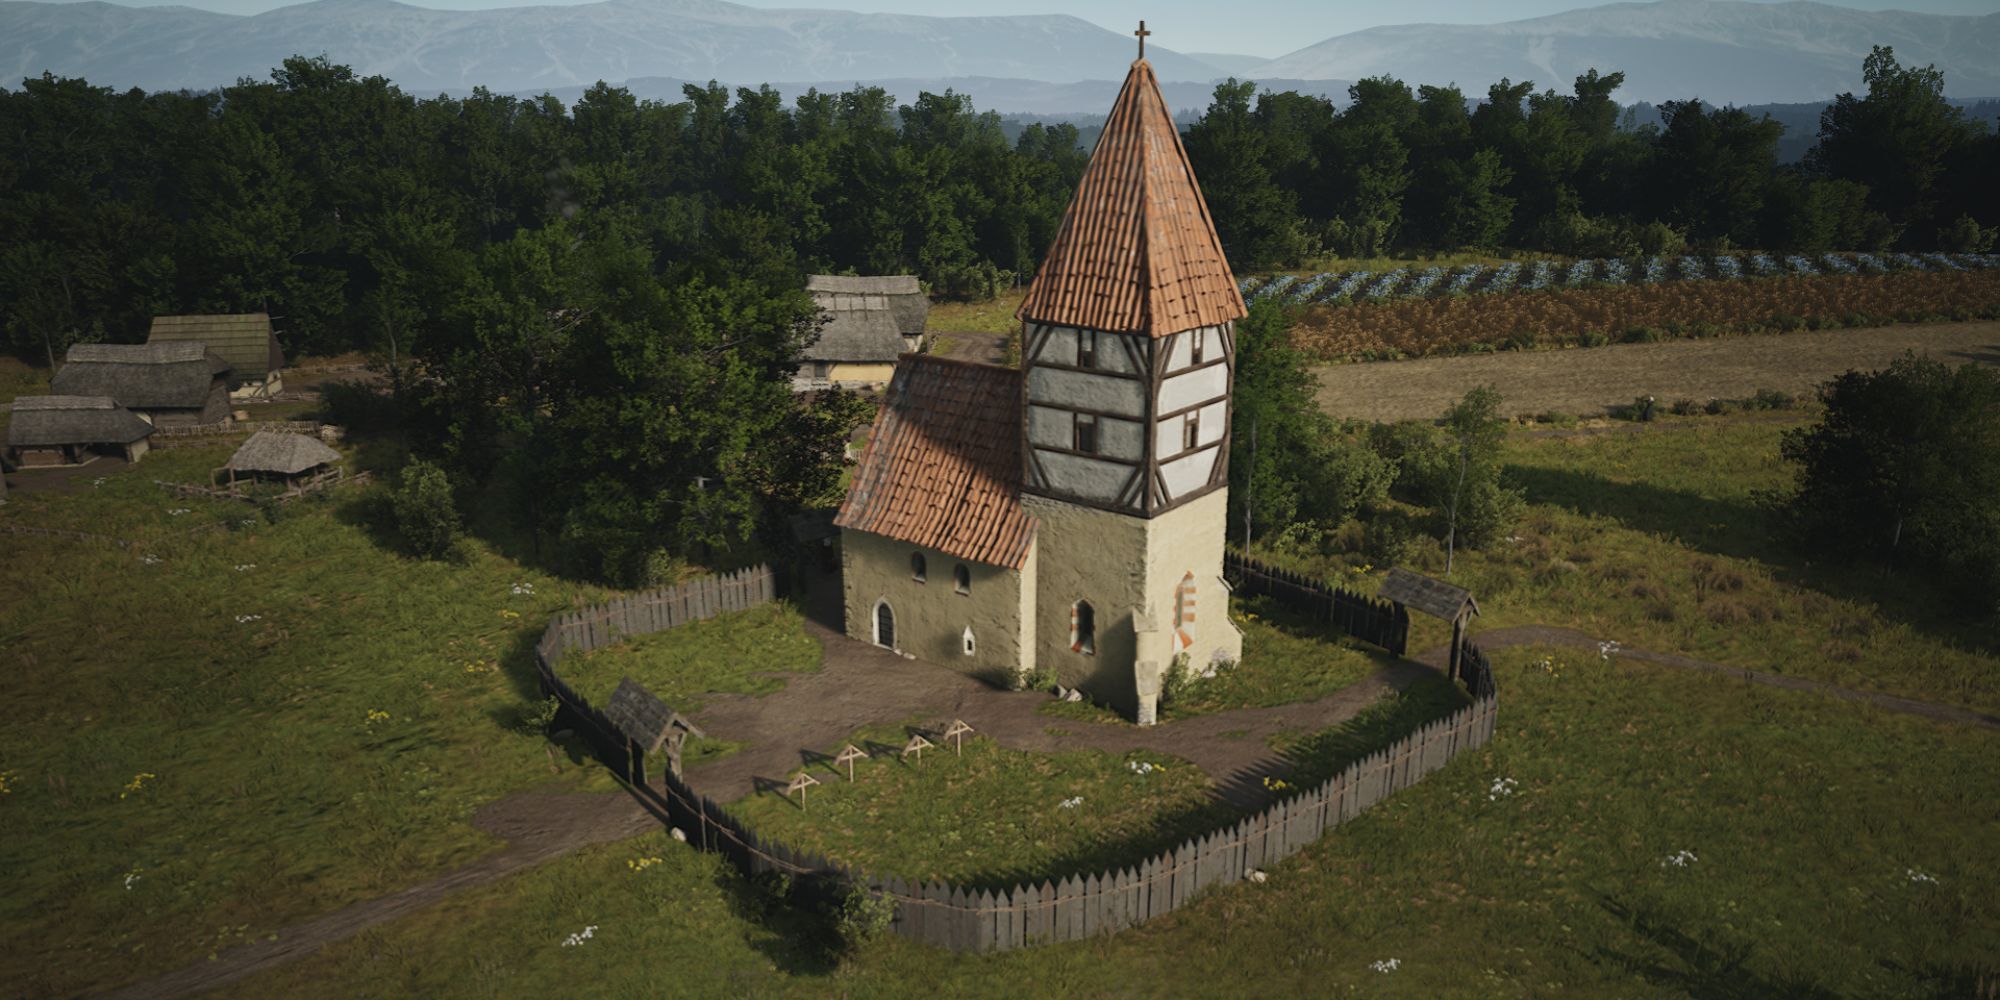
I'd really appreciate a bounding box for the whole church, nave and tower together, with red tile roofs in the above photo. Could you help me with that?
[836,56,1244,722]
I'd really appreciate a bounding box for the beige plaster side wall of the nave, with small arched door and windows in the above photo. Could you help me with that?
[840,528,1034,672]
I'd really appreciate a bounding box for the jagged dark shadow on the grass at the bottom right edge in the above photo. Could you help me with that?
[1588,898,1840,1000]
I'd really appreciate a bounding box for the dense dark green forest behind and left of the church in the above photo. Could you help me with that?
[0,50,2000,582]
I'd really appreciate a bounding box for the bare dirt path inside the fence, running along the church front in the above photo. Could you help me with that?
[688,622,1436,806]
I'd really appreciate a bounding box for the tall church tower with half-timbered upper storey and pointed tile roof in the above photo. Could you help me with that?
[1016,43,1244,722]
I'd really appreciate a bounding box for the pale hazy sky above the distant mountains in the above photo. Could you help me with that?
[62,0,2000,58]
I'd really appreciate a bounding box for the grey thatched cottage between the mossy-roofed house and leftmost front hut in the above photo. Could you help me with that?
[48,344,230,426]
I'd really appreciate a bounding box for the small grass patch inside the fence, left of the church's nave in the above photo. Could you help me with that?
[556,602,820,712]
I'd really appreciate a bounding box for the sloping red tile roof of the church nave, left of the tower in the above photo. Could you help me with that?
[834,354,1036,570]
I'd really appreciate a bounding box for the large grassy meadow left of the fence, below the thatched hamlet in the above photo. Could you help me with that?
[0,444,636,996]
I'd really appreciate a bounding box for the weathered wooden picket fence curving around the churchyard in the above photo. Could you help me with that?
[536,566,1498,952]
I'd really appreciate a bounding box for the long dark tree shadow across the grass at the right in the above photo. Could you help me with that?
[1506,466,1996,654]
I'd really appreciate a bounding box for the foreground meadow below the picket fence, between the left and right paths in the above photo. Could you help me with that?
[207,650,2000,998]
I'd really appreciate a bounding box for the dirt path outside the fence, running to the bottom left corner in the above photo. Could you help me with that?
[102,792,660,1000]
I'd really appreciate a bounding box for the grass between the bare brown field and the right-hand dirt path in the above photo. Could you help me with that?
[1274,412,2000,712]
